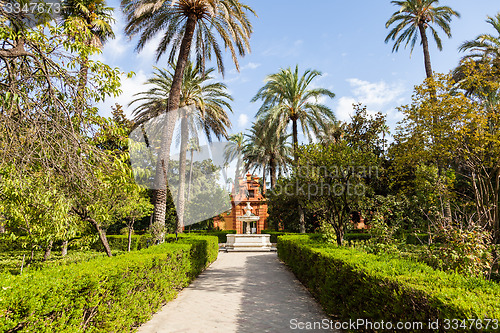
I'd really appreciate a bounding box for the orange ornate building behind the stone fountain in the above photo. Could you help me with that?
[214,173,269,234]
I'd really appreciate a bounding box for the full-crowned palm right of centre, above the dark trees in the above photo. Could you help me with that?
[252,65,335,162]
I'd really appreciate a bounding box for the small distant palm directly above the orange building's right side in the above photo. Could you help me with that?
[243,120,292,189]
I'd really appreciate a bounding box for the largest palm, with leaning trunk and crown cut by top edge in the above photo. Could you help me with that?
[121,0,255,239]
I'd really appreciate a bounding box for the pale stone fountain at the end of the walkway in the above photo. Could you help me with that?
[226,201,271,251]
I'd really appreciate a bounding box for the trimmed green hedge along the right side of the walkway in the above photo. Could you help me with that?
[278,236,500,332]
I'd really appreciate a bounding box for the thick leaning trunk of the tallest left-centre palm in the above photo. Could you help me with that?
[153,14,196,237]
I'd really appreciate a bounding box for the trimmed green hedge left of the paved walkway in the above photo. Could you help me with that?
[0,237,217,332]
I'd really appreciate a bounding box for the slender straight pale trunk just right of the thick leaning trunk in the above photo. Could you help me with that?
[177,111,189,233]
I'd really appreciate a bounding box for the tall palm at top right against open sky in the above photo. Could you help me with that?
[385,0,460,78]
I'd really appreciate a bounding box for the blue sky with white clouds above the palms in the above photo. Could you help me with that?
[95,0,500,141]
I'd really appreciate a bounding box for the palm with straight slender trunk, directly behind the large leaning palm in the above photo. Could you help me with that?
[129,61,232,232]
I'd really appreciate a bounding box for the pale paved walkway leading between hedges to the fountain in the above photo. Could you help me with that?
[138,252,340,333]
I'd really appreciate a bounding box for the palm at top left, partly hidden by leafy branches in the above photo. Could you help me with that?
[61,0,115,96]
